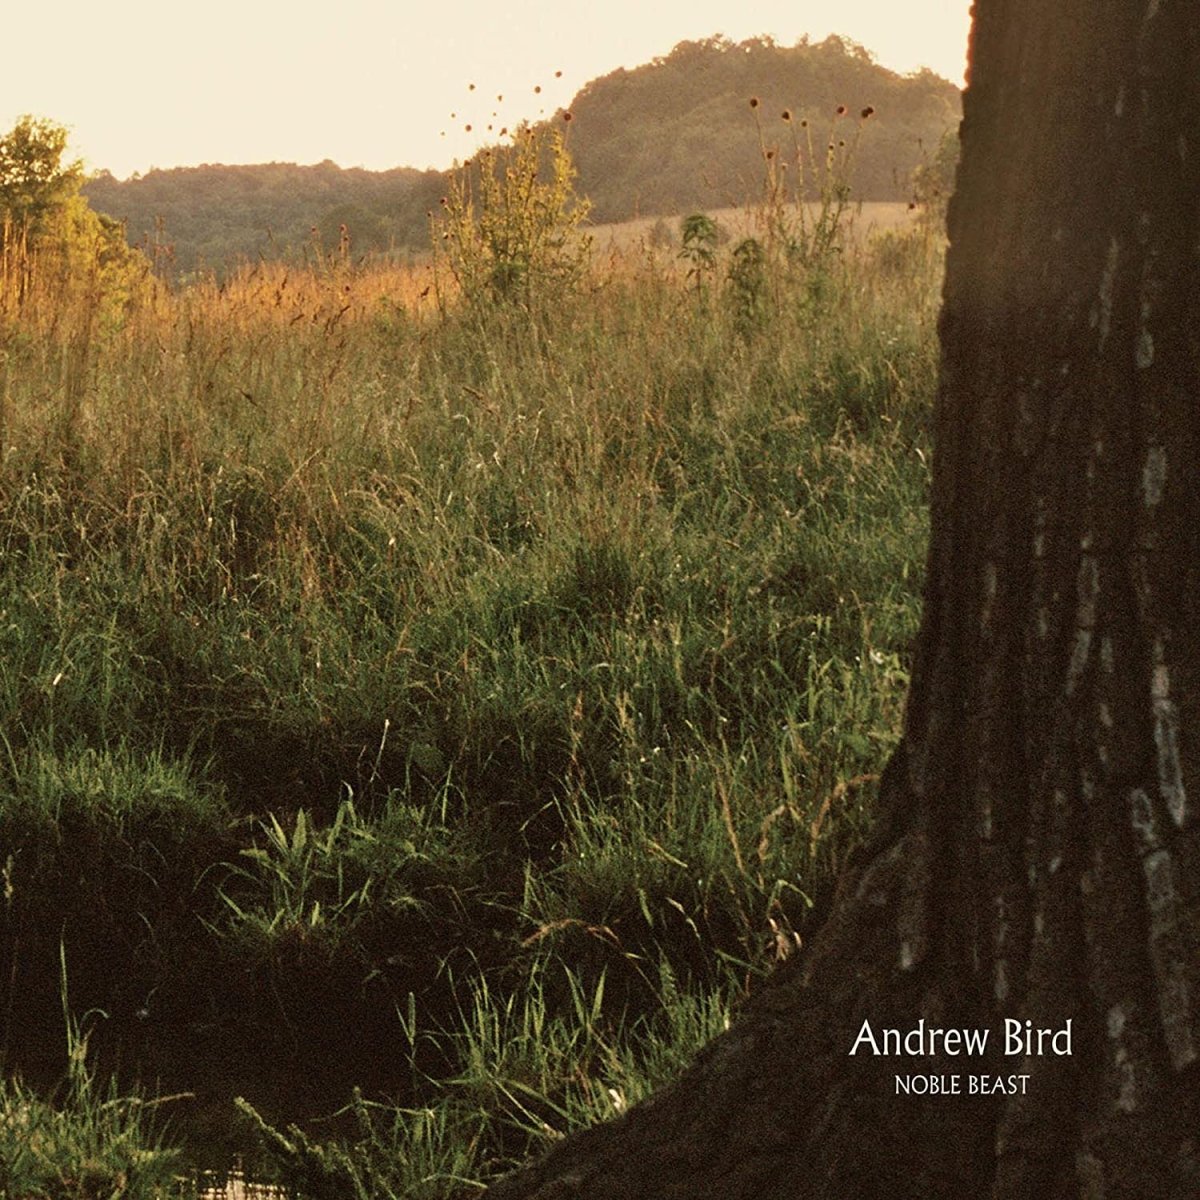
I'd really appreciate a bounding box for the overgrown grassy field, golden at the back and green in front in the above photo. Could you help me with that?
[0,184,940,1198]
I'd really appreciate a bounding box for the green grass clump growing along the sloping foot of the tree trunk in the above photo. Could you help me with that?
[238,958,737,1200]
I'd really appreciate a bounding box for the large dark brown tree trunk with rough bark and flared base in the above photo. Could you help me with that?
[488,0,1200,1200]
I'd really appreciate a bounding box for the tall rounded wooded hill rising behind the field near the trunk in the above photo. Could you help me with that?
[571,37,961,221]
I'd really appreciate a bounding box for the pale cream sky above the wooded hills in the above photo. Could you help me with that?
[0,0,970,178]
